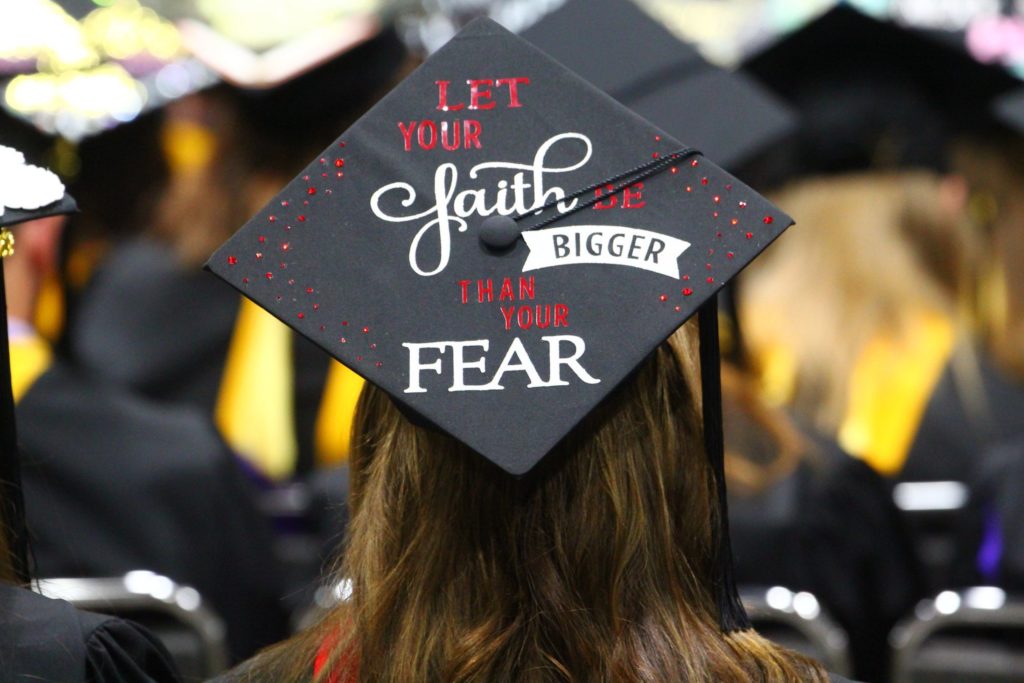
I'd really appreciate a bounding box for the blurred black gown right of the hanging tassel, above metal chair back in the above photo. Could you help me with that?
[729,436,925,681]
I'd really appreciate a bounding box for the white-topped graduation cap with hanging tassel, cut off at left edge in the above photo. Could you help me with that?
[0,145,76,582]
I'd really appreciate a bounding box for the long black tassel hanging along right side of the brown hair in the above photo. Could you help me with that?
[697,297,751,634]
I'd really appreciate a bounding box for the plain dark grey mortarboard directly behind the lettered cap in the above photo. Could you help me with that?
[522,0,796,166]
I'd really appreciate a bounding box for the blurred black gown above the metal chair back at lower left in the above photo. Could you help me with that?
[16,360,286,659]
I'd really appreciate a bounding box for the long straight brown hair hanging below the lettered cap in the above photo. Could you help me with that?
[235,326,826,683]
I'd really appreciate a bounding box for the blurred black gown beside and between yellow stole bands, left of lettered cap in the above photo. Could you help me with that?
[70,239,330,473]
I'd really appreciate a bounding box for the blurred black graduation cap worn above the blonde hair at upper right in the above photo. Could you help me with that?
[743,4,1019,172]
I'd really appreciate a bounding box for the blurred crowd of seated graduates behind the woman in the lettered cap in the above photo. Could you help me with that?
[6,0,1024,682]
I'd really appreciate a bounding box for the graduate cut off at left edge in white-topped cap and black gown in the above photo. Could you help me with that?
[0,145,178,683]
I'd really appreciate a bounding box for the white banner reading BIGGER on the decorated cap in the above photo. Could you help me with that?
[522,225,690,280]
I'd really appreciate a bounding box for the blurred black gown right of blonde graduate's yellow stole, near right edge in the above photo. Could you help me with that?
[898,355,1024,481]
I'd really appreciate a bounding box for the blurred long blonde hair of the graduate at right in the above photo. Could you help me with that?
[739,171,977,434]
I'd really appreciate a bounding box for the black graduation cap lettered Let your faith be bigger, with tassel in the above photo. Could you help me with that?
[201,19,792,631]
